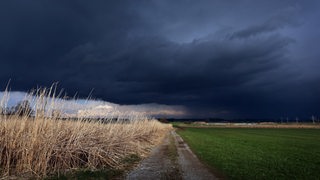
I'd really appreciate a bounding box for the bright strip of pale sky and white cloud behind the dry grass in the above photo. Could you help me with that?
[0,91,188,118]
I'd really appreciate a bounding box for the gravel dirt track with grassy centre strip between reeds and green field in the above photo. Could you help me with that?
[126,131,218,180]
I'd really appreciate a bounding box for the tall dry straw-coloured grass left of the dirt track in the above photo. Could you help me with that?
[0,86,171,177]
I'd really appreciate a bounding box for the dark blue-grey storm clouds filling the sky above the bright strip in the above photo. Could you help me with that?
[0,0,320,118]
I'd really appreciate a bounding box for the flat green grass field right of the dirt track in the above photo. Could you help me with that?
[177,128,320,180]
